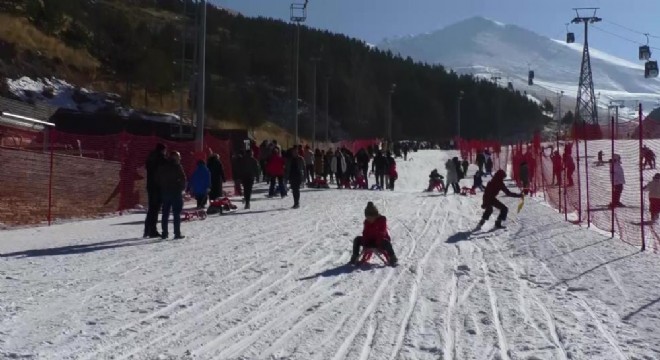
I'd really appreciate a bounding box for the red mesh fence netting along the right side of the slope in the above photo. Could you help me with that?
[511,112,660,251]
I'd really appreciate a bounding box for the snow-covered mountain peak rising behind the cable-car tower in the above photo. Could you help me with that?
[378,17,660,121]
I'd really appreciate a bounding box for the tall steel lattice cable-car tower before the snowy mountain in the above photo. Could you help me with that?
[572,8,603,125]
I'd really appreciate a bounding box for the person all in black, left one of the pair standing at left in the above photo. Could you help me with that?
[144,144,167,237]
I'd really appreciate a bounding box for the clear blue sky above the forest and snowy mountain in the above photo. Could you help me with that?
[211,0,660,60]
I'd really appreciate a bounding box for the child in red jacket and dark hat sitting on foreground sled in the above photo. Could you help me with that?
[349,201,397,266]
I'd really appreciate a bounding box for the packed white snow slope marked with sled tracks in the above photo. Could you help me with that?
[0,151,660,360]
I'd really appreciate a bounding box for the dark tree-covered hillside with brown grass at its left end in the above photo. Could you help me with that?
[0,0,547,139]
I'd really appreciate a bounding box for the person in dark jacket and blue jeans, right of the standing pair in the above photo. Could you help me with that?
[158,151,186,240]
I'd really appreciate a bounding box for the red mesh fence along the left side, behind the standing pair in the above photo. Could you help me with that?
[0,130,232,225]
